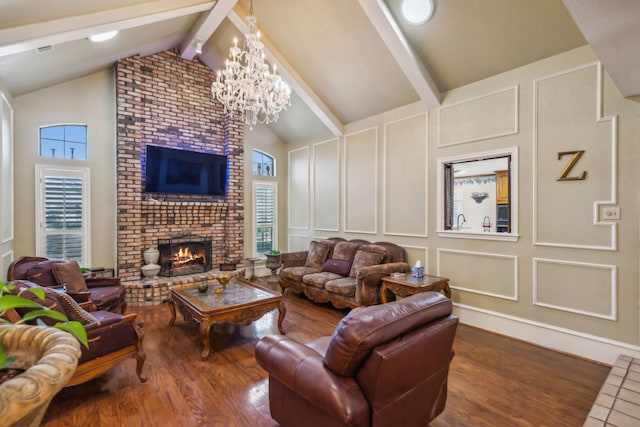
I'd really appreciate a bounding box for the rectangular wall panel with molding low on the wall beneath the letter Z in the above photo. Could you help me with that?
[533,258,618,320]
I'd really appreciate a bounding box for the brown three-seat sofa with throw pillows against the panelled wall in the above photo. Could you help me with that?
[280,237,411,308]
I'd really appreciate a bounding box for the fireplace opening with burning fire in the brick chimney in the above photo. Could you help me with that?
[158,234,211,277]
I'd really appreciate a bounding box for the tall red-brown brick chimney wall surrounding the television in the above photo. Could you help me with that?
[116,51,244,281]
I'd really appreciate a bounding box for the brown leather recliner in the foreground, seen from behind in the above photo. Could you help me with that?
[255,292,458,427]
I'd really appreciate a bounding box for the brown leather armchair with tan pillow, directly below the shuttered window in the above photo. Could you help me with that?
[7,256,127,314]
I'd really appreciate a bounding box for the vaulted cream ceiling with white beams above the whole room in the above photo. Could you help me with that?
[0,0,640,142]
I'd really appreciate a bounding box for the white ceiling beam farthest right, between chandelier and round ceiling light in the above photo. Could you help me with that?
[358,0,440,108]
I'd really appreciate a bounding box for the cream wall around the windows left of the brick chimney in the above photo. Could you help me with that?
[14,70,116,267]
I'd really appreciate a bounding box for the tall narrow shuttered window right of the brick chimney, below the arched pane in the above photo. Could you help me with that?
[253,182,278,255]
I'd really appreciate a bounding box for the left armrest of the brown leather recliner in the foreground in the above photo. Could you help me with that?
[255,335,370,424]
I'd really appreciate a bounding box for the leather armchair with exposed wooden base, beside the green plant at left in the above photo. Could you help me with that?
[7,280,147,386]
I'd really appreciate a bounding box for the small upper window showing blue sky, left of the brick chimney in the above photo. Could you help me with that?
[40,125,87,160]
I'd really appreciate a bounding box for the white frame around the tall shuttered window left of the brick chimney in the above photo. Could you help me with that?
[35,164,91,267]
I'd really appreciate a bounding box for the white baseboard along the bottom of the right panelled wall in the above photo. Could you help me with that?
[453,303,640,365]
